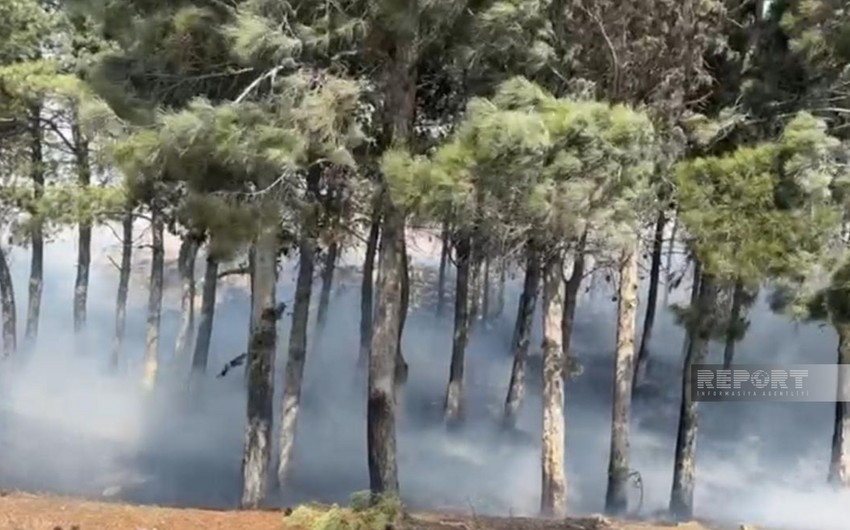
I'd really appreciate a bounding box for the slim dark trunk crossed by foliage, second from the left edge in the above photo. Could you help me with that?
[24,105,44,347]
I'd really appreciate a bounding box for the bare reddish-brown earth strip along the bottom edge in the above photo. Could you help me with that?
[0,493,737,530]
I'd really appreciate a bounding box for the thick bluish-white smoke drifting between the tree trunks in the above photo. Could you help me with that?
[0,221,850,530]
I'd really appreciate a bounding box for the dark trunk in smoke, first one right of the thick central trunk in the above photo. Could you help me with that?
[445,235,471,425]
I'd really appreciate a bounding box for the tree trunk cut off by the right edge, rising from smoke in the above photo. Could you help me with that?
[827,324,850,488]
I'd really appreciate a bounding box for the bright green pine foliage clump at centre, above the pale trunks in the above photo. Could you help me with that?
[382,78,655,254]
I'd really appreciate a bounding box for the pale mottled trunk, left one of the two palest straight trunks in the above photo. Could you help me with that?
[540,253,567,517]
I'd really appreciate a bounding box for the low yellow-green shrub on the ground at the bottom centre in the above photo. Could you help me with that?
[286,492,404,530]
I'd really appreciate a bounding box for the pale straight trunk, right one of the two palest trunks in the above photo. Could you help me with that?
[605,242,638,515]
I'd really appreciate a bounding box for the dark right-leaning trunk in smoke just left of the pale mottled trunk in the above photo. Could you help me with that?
[504,243,540,428]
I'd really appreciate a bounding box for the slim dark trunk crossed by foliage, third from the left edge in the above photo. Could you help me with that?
[71,111,91,334]
